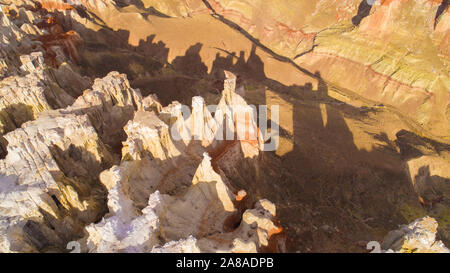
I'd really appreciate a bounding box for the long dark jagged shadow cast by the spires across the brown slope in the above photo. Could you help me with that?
[39,7,450,252]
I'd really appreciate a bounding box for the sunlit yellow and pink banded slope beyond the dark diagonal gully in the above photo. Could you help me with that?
[135,0,450,140]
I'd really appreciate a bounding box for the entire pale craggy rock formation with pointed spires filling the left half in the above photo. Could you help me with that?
[0,0,281,252]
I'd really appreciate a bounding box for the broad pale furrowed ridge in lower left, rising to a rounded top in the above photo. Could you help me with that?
[1,69,148,251]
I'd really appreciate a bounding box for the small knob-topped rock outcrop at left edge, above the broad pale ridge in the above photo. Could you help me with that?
[0,52,85,133]
